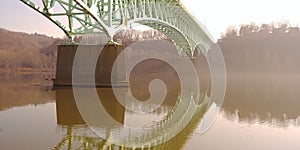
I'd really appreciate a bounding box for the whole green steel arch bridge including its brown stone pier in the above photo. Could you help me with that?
[20,0,215,87]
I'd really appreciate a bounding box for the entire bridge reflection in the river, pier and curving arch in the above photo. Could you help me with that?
[55,88,208,149]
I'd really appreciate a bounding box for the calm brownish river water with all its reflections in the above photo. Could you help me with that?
[0,74,300,150]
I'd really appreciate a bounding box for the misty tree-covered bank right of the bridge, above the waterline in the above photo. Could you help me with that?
[219,22,300,74]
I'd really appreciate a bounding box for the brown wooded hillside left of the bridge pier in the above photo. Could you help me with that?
[0,28,61,69]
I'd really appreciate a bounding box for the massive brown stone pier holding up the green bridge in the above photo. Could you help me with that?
[53,44,128,87]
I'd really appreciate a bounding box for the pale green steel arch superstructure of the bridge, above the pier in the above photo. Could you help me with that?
[20,0,214,56]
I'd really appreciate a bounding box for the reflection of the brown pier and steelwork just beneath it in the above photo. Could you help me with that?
[54,88,125,149]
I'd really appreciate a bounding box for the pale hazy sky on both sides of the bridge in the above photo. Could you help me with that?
[0,0,300,38]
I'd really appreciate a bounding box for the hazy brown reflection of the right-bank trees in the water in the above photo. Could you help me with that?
[223,75,300,127]
